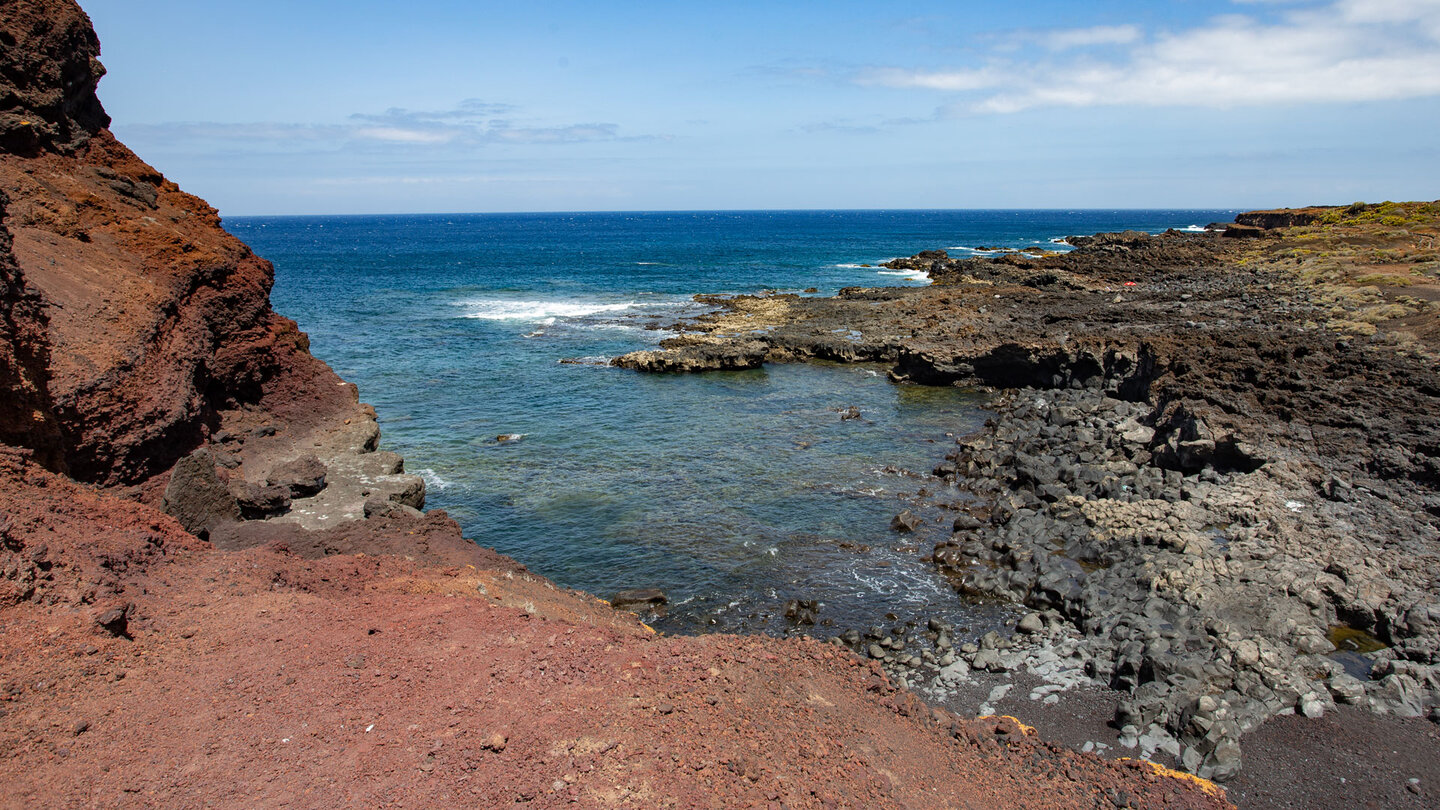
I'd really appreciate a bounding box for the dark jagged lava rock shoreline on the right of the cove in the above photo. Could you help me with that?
[615,203,1440,780]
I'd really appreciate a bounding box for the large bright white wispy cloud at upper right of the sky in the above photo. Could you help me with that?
[852,0,1440,112]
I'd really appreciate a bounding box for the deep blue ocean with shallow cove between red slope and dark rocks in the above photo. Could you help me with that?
[225,210,1237,636]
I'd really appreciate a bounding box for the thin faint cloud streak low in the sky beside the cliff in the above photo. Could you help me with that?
[125,99,657,151]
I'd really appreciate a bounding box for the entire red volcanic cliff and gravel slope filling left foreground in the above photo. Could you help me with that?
[0,0,1225,809]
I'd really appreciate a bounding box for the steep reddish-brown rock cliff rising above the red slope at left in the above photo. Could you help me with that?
[0,0,354,484]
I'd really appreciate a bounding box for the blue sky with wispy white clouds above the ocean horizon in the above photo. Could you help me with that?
[82,0,1440,215]
